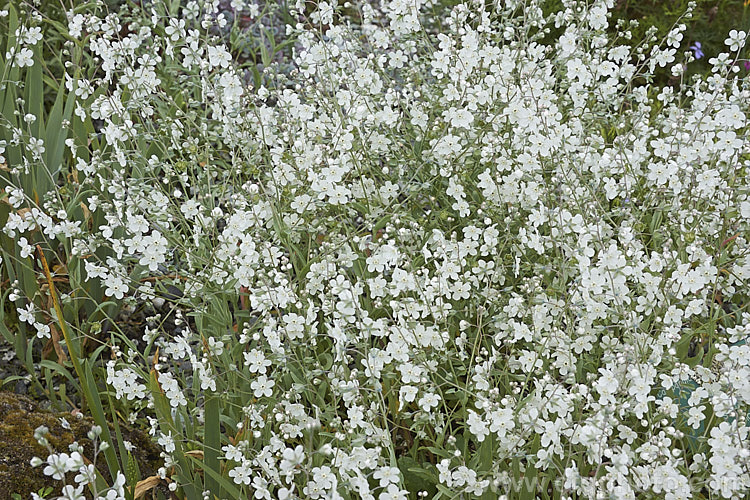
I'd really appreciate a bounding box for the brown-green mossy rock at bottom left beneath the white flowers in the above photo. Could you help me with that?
[0,391,161,498]
